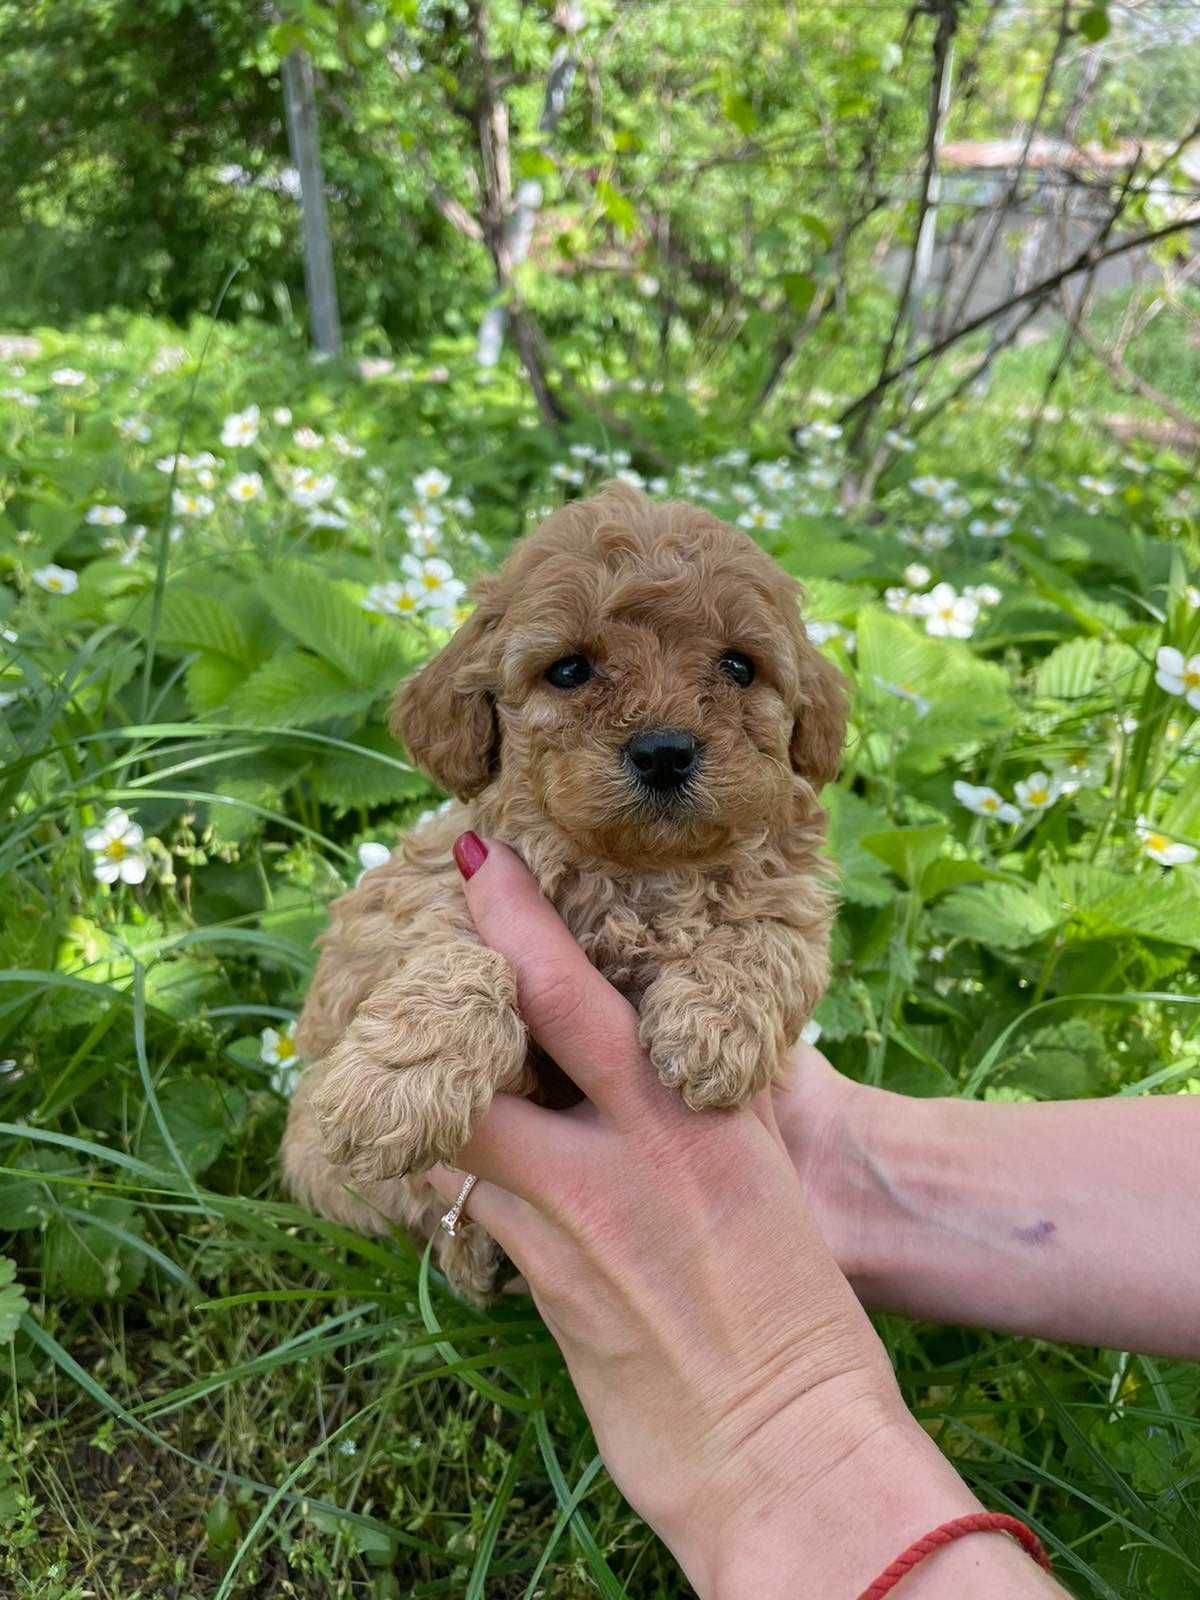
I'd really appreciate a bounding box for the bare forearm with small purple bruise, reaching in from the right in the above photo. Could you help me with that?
[829,1086,1200,1358]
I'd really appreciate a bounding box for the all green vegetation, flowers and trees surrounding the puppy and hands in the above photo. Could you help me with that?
[0,0,1200,1600]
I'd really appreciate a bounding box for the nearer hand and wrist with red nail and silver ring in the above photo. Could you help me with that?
[430,845,1062,1600]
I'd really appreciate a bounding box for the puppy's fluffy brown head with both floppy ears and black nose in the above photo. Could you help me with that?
[392,485,845,869]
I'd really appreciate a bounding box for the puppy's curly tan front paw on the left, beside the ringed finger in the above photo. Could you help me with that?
[312,946,530,1184]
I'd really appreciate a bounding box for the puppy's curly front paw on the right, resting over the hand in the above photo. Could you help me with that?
[638,971,782,1110]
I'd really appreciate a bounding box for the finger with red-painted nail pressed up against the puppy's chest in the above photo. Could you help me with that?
[454,834,650,1110]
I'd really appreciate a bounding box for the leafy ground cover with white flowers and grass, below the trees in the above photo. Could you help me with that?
[0,318,1200,1600]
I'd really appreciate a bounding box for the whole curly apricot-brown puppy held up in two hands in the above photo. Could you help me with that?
[283,483,845,1294]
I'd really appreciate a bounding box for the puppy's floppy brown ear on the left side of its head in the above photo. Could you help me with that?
[387,592,501,800]
